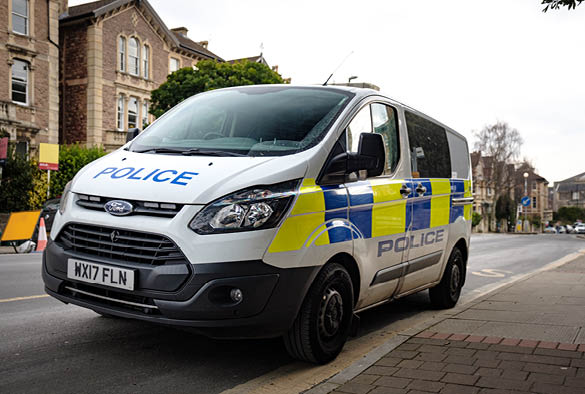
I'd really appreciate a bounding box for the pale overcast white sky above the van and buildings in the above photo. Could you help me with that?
[69,0,585,186]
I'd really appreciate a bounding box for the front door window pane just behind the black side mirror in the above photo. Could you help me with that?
[372,103,400,175]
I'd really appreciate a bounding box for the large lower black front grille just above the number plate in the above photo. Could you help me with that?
[56,223,186,265]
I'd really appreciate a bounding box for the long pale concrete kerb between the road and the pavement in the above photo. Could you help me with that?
[303,249,585,394]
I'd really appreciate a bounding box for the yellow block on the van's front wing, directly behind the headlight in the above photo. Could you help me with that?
[268,212,329,253]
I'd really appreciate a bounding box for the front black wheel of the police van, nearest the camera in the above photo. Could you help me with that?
[284,263,353,364]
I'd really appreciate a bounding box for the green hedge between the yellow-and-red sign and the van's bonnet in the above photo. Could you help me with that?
[50,144,106,198]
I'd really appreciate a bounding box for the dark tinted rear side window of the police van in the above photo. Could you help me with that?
[405,111,451,178]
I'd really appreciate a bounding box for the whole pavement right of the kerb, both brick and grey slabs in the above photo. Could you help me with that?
[309,252,585,394]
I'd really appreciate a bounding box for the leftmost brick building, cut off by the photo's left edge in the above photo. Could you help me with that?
[0,0,67,155]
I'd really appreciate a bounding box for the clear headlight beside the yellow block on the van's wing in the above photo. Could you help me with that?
[189,180,300,235]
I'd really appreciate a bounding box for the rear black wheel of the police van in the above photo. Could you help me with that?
[429,248,465,309]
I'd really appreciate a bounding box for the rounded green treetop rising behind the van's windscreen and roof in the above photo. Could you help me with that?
[150,60,284,117]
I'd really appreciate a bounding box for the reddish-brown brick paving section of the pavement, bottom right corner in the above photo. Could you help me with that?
[334,332,585,394]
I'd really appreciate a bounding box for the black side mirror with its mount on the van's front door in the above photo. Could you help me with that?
[319,133,386,185]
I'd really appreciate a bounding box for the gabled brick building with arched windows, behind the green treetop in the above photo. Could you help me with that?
[60,0,223,150]
